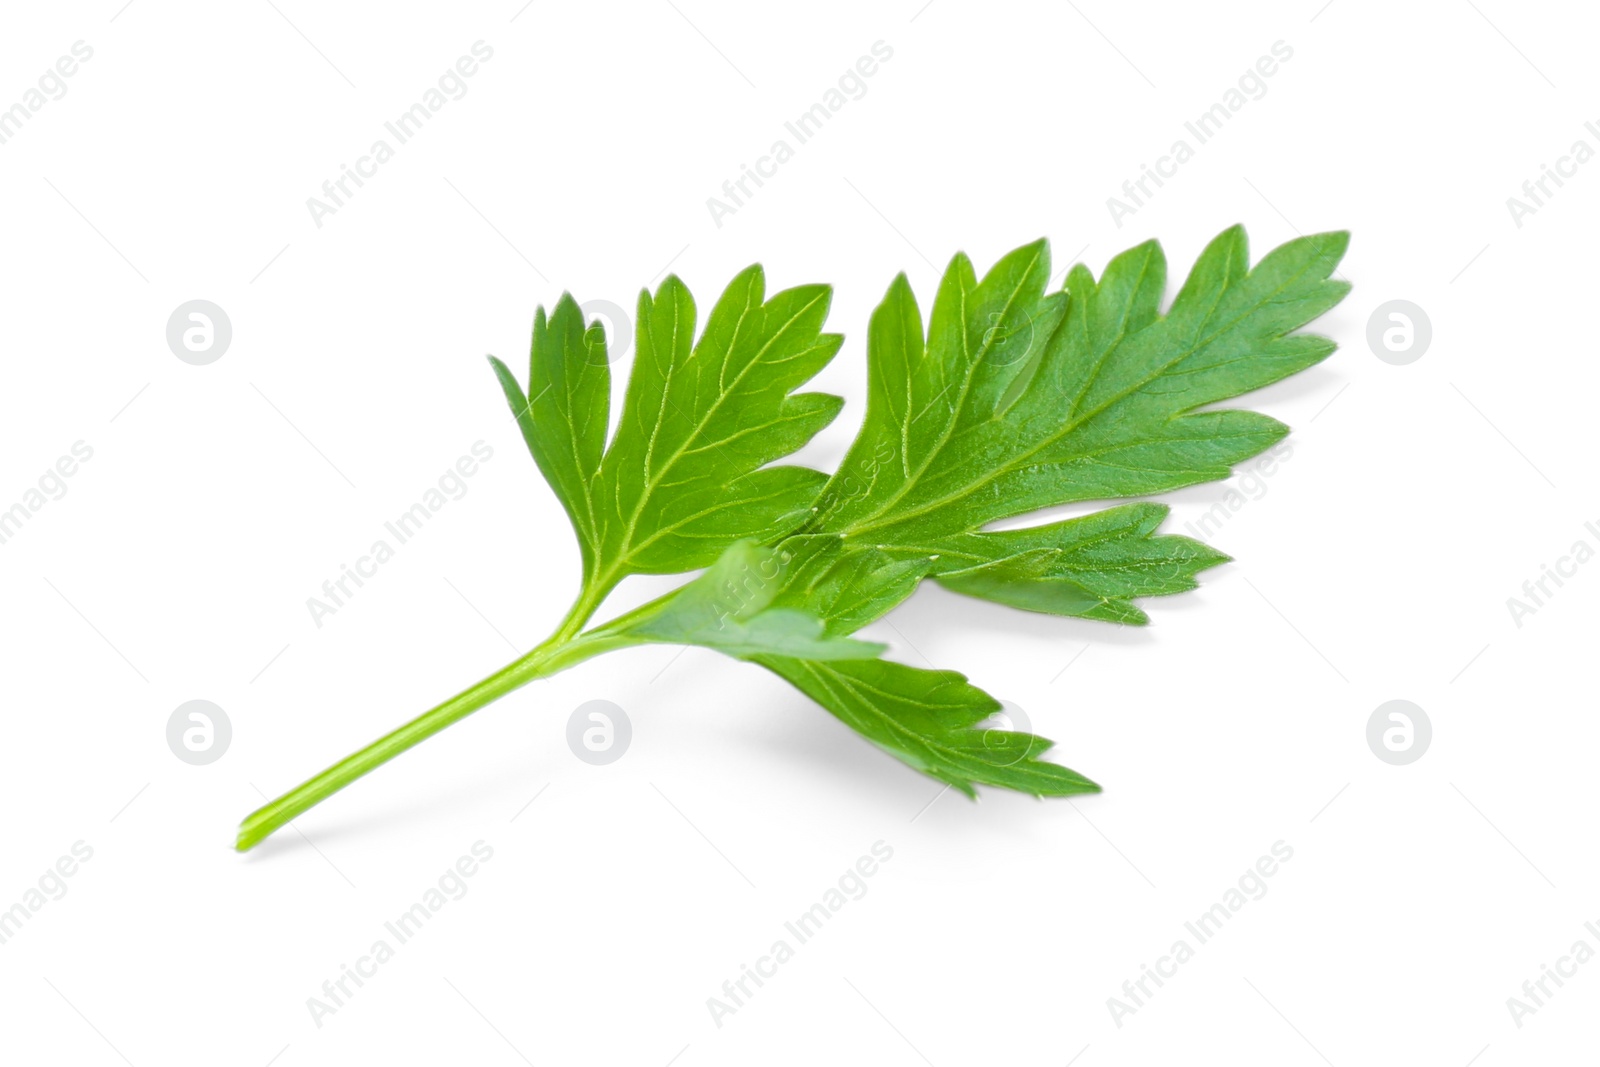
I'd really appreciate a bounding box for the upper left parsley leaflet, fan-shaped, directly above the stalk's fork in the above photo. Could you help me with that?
[493,266,845,600]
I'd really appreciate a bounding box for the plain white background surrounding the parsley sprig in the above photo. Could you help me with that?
[0,0,1600,1067]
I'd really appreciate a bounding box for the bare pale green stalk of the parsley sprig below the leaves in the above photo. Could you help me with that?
[234,592,634,853]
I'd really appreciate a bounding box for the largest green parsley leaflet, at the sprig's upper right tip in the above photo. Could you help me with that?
[787,227,1349,622]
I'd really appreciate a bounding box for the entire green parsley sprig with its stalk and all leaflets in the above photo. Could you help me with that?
[238,227,1349,849]
